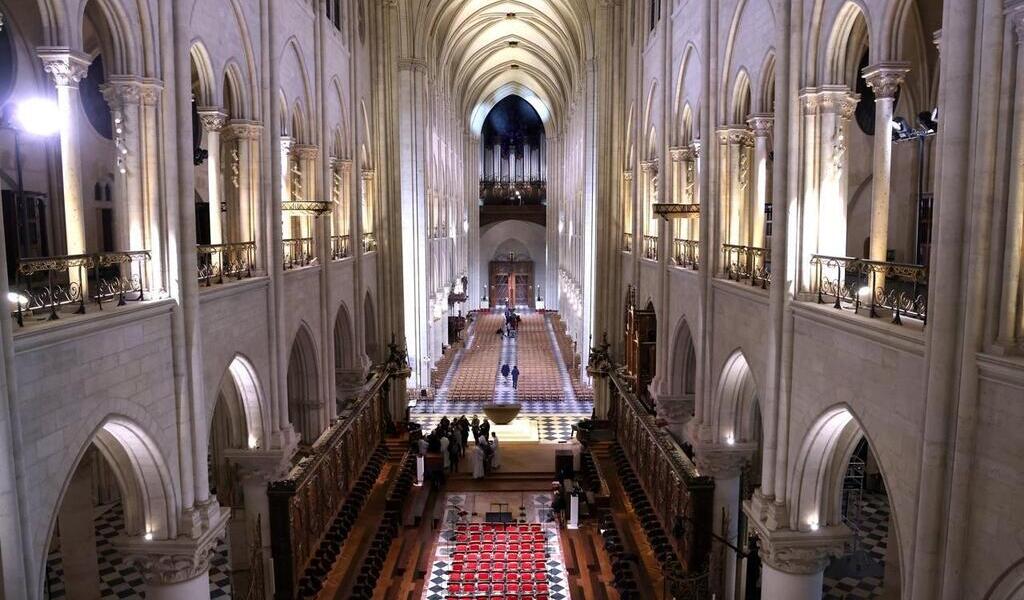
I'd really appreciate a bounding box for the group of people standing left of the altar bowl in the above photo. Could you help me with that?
[419,415,501,479]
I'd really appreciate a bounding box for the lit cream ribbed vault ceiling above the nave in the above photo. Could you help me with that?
[417,0,589,134]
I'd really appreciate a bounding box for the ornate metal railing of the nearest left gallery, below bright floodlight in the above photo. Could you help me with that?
[9,250,150,327]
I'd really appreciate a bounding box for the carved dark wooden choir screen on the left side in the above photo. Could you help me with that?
[267,371,390,600]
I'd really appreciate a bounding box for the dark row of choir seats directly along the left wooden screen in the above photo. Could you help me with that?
[299,446,387,598]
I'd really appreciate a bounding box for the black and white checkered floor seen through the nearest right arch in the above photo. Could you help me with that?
[823,491,889,600]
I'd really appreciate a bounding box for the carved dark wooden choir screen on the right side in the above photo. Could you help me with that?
[608,368,715,573]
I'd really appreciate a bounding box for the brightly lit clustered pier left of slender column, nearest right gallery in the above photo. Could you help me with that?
[815,85,856,256]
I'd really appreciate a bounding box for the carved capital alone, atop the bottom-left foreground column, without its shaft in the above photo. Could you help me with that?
[114,508,230,586]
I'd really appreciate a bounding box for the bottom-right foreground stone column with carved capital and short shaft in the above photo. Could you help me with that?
[751,520,850,600]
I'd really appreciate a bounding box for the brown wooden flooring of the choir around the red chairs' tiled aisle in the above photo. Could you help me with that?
[333,438,664,600]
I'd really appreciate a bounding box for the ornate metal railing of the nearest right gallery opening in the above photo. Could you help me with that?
[811,254,928,325]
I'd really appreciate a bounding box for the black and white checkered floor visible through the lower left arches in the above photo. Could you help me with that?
[44,502,231,600]
